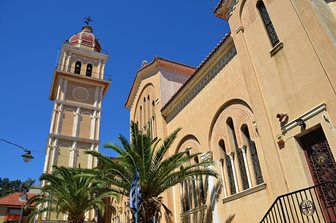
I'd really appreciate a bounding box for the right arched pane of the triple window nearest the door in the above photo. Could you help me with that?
[241,124,264,184]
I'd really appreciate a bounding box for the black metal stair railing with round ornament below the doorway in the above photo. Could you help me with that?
[260,182,336,223]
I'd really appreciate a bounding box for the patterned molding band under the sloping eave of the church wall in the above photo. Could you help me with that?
[166,47,237,122]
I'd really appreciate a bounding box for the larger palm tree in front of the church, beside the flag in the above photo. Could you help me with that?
[88,122,216,222]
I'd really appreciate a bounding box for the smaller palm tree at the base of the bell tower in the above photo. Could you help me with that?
[27,167,118,223]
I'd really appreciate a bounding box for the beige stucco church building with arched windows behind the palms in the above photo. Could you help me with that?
[124,0,336,222]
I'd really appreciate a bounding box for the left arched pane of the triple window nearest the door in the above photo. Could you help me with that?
[218,139,237,194]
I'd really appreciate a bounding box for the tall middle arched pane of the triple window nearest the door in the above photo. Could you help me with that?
[226,118,249,190]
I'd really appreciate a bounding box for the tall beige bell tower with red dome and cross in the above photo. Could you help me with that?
[43,20,111,173]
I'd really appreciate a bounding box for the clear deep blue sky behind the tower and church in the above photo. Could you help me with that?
[0,0,229,183]
